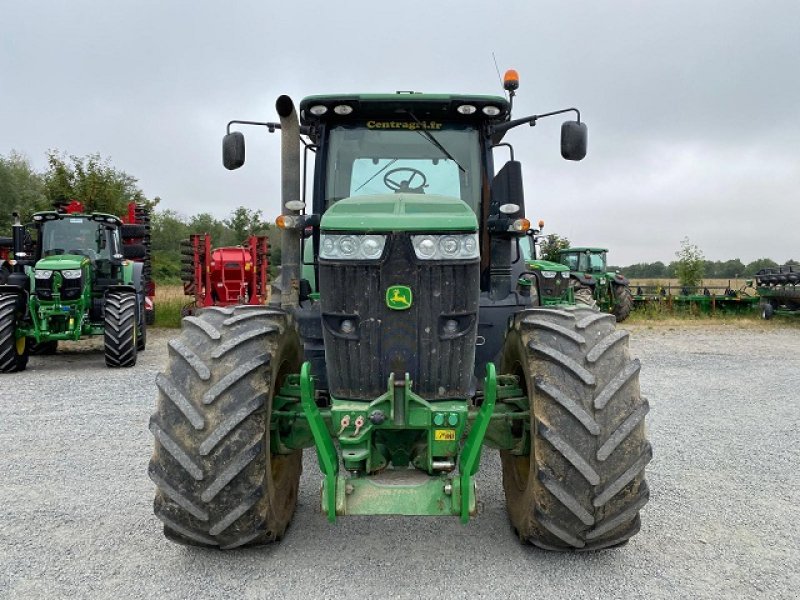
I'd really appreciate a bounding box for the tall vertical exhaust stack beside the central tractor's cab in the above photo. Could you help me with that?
[275,95,304,309]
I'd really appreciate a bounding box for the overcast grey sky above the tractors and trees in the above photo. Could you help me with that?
[0,0,800,264]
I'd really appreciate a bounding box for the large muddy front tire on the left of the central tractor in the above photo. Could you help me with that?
[148,306,302,549]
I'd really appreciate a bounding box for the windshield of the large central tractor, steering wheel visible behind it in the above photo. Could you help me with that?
[325,120,480,212]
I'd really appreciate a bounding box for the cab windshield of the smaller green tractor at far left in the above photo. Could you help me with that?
[40,217,112,260]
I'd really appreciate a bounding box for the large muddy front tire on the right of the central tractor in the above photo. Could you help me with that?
[501,307,652,551]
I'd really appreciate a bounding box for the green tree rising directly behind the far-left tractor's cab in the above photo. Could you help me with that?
[44,151,159,215]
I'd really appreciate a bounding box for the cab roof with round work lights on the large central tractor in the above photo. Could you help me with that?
[300,92,510,125]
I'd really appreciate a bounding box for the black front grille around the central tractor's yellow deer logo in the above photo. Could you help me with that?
[320,235,479,399]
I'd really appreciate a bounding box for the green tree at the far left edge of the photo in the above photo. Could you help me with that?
[0,152,50,230]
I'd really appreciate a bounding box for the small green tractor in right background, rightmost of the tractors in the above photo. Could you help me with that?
[558,248,633,323]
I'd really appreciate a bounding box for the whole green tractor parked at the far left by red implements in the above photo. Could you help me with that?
[0,211,146,373]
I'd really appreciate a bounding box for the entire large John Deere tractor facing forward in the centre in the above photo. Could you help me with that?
[149,77,651,550]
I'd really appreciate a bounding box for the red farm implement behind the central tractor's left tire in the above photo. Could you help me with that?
[181,234,269,315]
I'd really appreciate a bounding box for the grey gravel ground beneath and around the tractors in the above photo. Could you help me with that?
[0,325,800,600]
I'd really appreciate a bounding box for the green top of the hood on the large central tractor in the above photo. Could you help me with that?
[321,194,478,232]
